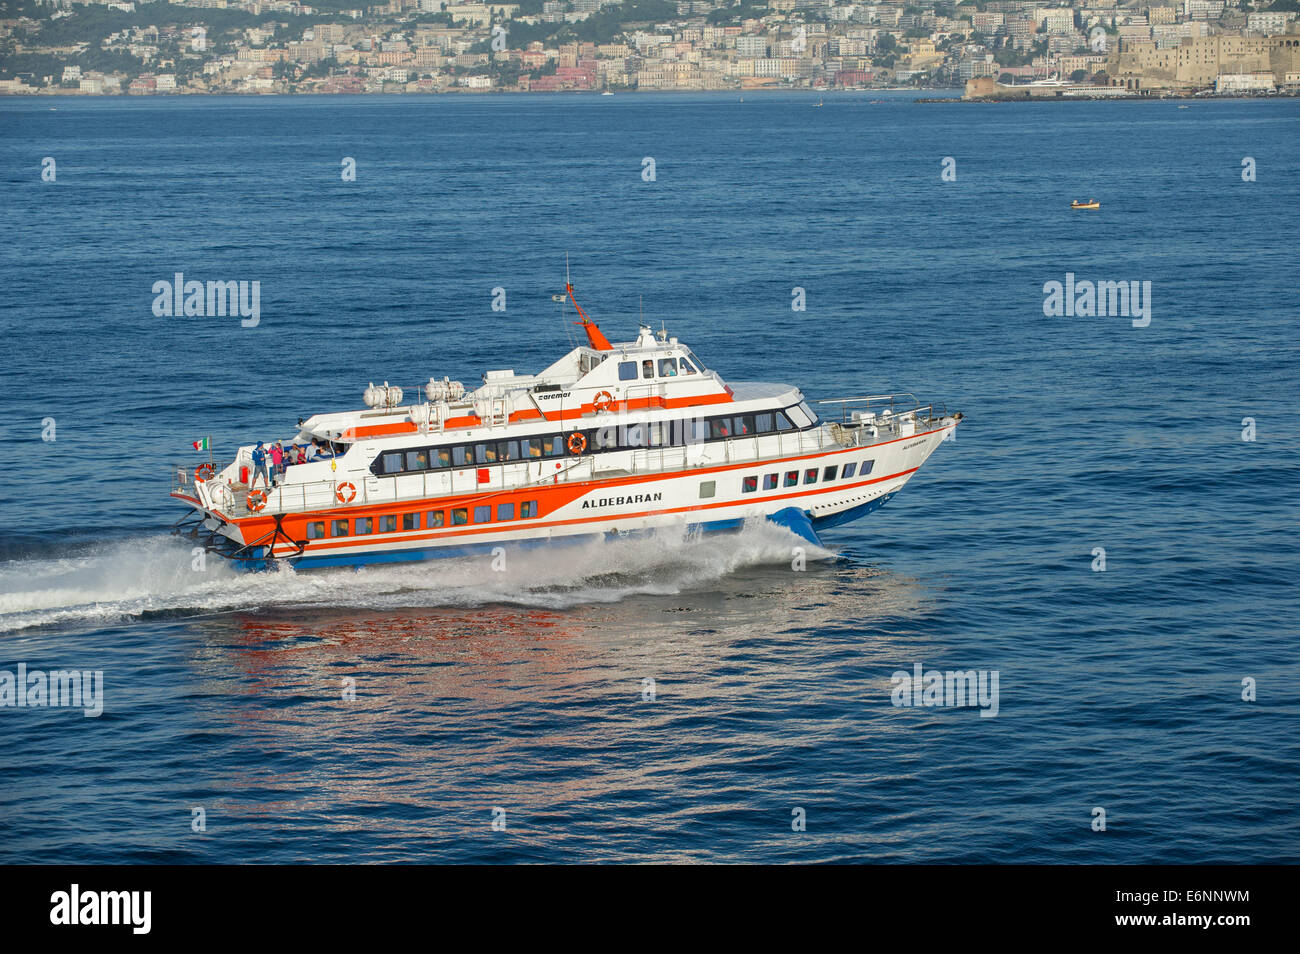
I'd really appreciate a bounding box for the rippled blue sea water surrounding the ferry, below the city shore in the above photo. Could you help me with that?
[0,94,1300,863]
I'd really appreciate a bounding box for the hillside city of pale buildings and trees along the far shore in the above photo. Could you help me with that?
[0,0,1300,95]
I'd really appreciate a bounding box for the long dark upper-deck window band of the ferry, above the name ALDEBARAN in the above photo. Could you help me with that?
[371,402,816,477]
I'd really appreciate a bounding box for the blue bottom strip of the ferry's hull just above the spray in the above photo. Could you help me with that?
[231,494,893,571]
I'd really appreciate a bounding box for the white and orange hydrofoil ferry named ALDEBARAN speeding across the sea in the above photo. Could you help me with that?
[172,283,962,569]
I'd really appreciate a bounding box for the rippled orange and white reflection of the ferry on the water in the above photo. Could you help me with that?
[172,559,935,863]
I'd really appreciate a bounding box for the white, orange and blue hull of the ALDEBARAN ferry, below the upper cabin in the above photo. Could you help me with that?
[174,419,957,568]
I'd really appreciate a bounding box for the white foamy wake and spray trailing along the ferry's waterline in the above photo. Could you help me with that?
[0,520,829,633]
